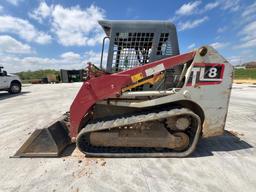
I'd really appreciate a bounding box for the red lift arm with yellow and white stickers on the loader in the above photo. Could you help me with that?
[69,51,196,141]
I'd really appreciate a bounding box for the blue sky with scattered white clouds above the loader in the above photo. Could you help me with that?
[0,0,256,72]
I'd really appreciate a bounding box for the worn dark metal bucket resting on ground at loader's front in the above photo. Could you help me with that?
[13,116,70,157]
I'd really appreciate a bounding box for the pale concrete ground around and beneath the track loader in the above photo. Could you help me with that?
[0,83,256,192]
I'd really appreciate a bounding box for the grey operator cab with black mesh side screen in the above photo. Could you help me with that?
[99,20,183,90]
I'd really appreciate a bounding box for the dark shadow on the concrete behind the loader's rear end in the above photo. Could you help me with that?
[191,131,253,157]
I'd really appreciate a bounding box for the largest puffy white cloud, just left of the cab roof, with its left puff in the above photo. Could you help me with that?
[29,2,105,46]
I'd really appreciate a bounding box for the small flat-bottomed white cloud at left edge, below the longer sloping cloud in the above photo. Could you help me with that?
[0,35,32,54]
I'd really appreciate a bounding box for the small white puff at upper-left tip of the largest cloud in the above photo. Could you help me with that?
[29,2,52,23]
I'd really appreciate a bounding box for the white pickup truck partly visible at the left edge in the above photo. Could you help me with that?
[0,66,22,94]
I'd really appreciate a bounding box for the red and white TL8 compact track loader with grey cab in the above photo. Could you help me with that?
[14,21,233,157]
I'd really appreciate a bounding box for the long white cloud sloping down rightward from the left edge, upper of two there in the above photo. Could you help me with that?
[0,16,51,44]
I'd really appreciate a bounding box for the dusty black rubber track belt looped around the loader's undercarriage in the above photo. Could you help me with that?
[77,108,201,157]
